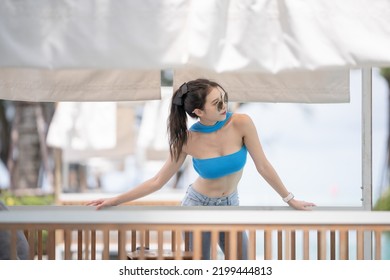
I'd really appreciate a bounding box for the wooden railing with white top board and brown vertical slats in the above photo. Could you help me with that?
[0,206,390,260]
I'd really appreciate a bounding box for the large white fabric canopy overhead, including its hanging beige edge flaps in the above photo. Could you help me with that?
[0,0,390,102]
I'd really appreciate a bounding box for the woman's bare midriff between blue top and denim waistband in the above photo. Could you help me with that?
[192,170,242,197]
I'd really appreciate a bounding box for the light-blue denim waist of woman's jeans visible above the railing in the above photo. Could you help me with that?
[181,185,239,206]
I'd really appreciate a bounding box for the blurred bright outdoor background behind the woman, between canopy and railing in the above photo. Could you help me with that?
[0,68,390,210]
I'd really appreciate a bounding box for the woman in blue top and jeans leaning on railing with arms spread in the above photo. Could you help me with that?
[88,79,314,259]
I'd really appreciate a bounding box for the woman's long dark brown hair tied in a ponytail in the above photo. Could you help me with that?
[168,79,227,160]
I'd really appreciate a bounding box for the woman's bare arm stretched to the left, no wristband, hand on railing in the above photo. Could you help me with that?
[87,152,187,209]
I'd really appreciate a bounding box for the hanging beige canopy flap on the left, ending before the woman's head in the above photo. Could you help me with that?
[0,68,161,102]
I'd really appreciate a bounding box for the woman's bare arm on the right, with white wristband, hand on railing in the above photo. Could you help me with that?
[237,114,315,210]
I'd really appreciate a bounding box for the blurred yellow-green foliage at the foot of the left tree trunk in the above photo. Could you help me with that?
[0,191,55,206]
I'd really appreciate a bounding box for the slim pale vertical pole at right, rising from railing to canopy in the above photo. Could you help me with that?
[362,68,372,260]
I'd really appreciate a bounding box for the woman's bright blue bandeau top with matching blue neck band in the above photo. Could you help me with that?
[190,112,247,179]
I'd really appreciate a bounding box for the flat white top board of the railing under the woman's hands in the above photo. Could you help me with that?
[0,206,390,225]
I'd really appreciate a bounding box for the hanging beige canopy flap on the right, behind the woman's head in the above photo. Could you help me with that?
[173,69,350,103]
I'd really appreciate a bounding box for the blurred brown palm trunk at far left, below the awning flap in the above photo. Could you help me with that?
[0,100,54,195]
